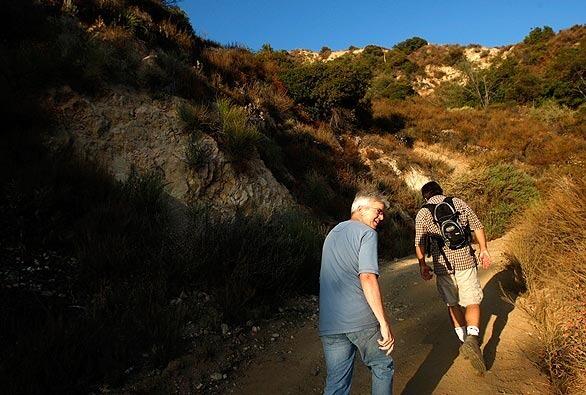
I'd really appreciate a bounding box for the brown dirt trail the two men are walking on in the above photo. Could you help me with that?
[228,239,551,395]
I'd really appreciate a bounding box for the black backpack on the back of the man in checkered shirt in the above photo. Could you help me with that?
[423,197,472,250]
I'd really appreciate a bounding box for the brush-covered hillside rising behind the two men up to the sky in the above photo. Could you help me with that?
[0,0,586,393]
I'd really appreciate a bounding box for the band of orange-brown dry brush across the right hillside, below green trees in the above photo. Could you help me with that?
[373,98,586,173]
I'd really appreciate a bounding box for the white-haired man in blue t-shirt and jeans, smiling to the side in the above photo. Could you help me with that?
[319,192,395,395]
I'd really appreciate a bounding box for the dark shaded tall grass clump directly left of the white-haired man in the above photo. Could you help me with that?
[186,208,325,322]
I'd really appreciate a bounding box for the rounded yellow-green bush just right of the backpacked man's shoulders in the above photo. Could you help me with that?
[446,164,539,239]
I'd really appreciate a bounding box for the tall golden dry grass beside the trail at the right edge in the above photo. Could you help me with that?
[507,177,586,394]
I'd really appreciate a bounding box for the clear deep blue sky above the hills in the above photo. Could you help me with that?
[178,0,586,50]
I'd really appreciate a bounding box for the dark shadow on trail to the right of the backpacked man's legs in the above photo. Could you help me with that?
[480,267,520,369]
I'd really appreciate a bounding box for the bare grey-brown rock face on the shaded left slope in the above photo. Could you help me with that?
[48,88,294,212]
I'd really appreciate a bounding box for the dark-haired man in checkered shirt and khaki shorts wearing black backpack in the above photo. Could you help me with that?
[415,181,491,373]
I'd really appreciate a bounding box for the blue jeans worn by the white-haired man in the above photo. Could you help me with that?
[321,327,395,395]
